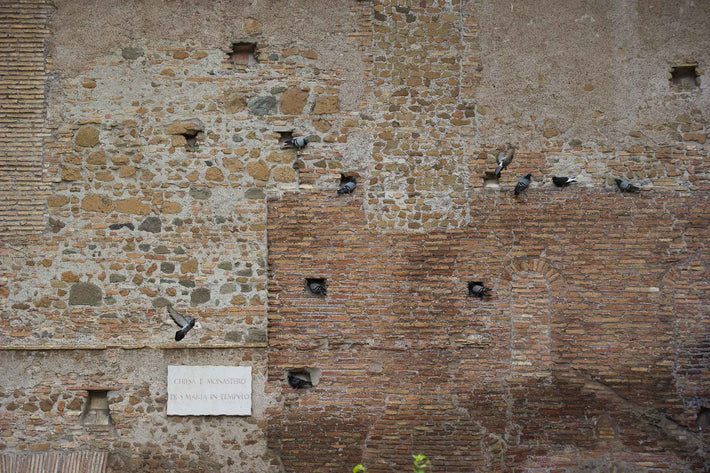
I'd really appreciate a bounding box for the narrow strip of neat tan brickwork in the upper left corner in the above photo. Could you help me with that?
[0,0,51,240]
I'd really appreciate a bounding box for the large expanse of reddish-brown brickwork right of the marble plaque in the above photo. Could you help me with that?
[267,189,710,472]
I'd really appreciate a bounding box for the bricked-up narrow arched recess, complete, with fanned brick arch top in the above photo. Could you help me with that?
[502,258,566,384]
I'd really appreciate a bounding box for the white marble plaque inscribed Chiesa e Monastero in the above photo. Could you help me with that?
[168,366,251,416]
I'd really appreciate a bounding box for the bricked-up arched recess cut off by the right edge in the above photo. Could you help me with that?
[661,258,710,425]
